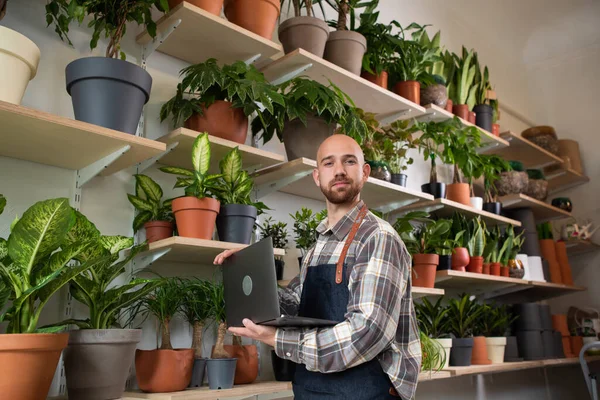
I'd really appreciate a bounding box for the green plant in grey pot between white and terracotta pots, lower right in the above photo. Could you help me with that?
[447,294,482,367]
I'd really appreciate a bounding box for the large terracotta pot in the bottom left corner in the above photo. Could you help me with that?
[0,333,69,400]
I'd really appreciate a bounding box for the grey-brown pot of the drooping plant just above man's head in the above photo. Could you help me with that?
[283,115,336,161]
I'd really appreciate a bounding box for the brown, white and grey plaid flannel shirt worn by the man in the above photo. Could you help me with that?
[275,201,421,400]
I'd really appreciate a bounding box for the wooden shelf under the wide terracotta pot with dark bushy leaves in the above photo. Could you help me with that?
[158,128,285,171]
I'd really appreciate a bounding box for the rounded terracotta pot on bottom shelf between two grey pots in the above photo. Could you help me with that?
[135,349,194,393]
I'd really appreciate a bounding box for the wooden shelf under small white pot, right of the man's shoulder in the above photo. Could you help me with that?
[397,199,521,226]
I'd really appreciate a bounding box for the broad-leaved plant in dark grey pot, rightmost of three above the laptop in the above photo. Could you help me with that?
[215,147,268,244]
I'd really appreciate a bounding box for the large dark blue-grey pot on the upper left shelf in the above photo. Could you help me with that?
[65,57,152,134]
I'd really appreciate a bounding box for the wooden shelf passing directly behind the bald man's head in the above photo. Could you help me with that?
[254,158,432,212]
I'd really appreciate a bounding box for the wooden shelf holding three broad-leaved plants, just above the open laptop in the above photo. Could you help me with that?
[140,236,285,265]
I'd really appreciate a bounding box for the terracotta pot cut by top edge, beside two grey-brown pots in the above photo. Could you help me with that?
[225,0,281,40]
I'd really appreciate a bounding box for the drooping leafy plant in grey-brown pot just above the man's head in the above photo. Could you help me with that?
[252,77,367,160]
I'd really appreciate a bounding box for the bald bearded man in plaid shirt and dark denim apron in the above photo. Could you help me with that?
[215,135,421,400]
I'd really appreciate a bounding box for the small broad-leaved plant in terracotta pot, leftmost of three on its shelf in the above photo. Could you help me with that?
[127,174,173,243]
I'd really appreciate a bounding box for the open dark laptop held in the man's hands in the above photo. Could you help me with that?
[223,237,337,328]
